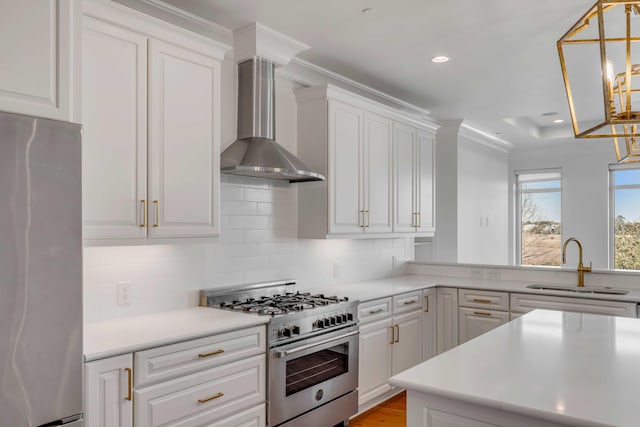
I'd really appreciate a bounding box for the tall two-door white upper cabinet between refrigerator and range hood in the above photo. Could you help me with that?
[82,0,229,239]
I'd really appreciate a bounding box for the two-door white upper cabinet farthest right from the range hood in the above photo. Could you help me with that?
[393,123,435,235]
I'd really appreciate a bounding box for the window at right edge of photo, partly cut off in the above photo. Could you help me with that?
[610,165,640,270]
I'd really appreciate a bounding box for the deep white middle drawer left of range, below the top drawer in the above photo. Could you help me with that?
[134,355,266,427]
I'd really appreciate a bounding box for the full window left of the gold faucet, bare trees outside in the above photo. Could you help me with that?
[516,170,562,266]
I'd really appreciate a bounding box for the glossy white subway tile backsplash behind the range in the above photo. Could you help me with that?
[83,175,414,322]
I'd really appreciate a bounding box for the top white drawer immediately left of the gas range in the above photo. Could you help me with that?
[134,326,266,387]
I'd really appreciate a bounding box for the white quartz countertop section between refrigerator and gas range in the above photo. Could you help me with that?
[84,307,269,362]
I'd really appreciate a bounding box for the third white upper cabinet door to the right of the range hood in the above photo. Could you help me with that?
[393,123,417,233]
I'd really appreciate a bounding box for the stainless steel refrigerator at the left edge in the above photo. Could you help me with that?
[0,112,82,427]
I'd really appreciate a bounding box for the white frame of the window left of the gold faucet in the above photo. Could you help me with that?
[514,168,564,268]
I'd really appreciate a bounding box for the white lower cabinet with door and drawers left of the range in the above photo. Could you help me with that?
[85,326,266,427]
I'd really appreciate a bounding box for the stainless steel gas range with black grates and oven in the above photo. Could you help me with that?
[200,280,358,427]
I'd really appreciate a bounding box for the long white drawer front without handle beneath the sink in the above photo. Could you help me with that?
[511,294,636,317]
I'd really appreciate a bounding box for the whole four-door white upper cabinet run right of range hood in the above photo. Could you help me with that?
[296,85,435,238]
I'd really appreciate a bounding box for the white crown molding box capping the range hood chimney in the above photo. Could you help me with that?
[233,22,311,66]
